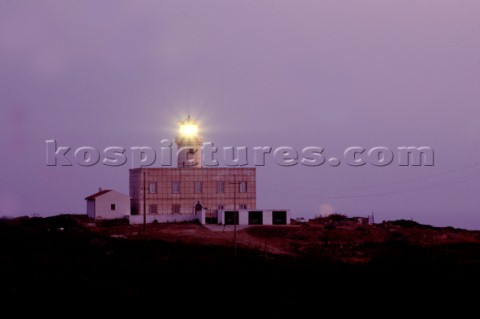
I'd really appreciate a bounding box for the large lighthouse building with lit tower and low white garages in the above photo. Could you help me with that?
[129,117,289,225]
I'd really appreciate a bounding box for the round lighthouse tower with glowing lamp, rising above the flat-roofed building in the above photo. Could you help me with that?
[175,115,203,168]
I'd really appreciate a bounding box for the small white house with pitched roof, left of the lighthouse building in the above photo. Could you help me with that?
[85,189,130,219]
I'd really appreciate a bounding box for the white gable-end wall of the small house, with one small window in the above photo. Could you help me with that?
[95,190,130,219]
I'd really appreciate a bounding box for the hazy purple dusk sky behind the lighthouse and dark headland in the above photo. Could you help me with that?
[0,0,480,229]
